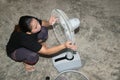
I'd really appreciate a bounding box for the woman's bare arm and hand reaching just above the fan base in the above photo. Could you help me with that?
[38,41,76,55]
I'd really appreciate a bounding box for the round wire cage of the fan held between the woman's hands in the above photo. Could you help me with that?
[51,9,75,44]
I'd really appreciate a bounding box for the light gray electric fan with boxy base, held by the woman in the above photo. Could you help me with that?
[51,9,87,80]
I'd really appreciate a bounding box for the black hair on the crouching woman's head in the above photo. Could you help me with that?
[18,15,38,32]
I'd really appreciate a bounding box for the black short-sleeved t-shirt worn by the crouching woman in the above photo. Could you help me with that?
[6,20,42,56]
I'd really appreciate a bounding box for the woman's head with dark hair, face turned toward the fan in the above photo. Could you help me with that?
[19,16,41,33]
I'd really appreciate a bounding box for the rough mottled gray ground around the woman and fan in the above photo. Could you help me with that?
[0,0,120,80]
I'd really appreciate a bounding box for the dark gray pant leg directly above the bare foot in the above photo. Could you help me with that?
[11,48,39,65]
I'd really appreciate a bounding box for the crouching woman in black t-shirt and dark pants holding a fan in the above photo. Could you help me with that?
[6,16,76,71]
